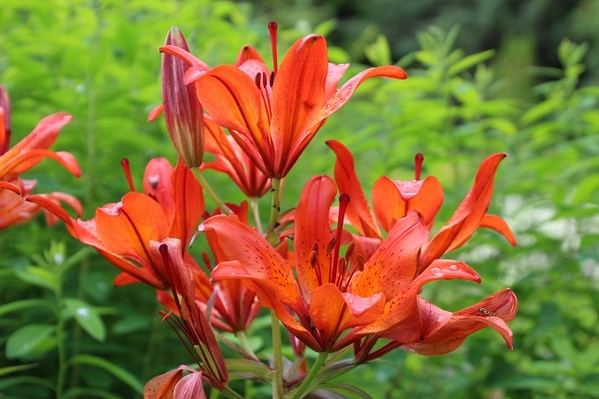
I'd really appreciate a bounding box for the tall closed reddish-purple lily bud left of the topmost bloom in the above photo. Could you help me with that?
[162,26,204,168]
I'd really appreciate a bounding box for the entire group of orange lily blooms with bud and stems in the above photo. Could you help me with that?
[0,23,517,398]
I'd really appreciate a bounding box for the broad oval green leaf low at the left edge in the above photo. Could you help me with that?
[6,324,56,359]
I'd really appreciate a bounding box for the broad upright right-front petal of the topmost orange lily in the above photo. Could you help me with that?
[271,35,328,177]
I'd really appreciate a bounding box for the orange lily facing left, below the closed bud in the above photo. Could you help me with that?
[28,160,204,290]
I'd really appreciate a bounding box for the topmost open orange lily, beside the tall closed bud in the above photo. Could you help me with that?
[171,23,407,179]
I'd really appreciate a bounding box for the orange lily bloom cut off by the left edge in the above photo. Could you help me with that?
[0,86,83,230]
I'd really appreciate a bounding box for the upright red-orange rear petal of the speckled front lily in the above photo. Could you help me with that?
[294,176,340,301]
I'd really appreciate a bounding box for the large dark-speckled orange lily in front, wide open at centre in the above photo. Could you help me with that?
[199,176,480,351]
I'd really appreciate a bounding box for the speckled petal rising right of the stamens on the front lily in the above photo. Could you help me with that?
[351,211,428,298]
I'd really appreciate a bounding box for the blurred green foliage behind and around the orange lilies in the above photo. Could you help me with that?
[0,0,599,399]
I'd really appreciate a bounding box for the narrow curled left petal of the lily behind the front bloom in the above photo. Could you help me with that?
[326,140,382,238]
